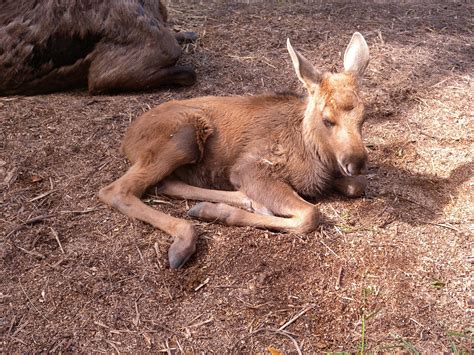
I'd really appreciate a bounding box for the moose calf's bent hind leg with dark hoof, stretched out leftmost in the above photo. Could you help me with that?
[99,125,203,268]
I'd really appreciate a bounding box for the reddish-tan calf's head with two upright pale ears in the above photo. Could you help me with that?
[287,32,369,176]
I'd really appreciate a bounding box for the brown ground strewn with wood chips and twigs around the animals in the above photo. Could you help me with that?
[0,1,474,354]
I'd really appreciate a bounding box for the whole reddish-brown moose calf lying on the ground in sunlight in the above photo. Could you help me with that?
[99,33,369,268]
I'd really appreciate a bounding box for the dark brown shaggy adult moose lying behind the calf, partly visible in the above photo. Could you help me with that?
[0,0,196,95]
